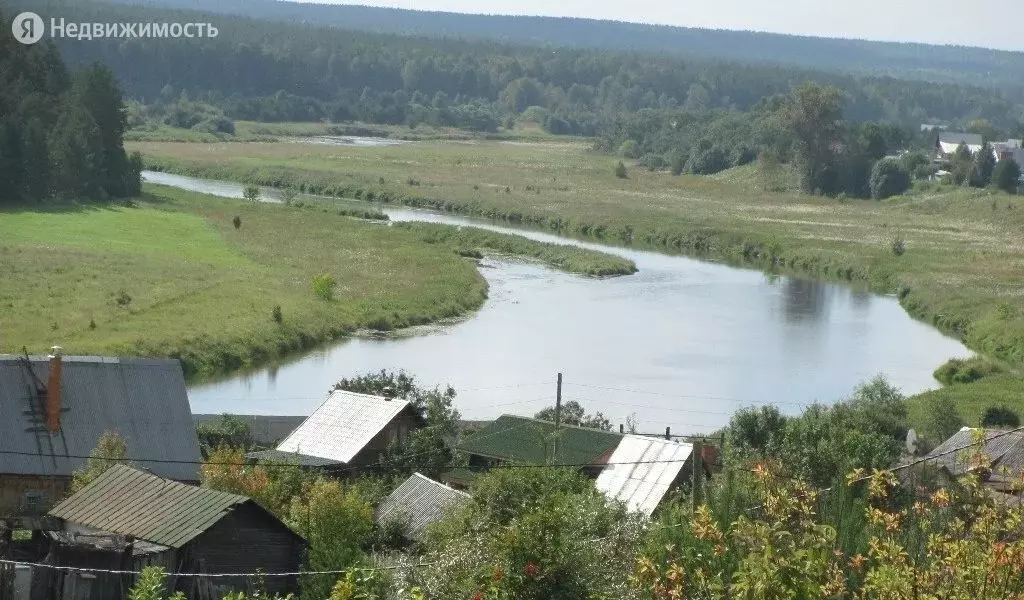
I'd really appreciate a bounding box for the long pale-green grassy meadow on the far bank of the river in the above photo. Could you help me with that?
[131,141,1024,419]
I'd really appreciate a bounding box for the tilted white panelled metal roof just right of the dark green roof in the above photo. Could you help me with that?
[595,435,693,516]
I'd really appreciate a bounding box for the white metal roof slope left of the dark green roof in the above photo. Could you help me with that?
[278,390,409,463]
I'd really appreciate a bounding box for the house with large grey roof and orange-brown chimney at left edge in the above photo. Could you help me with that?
[0,347,202,520]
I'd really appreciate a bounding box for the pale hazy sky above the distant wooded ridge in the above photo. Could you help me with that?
[301,0,1024,50]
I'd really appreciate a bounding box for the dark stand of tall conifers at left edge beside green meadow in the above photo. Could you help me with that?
[0,11,141,202]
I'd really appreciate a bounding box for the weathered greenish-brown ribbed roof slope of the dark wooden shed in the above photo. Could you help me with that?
[49,465,252,548]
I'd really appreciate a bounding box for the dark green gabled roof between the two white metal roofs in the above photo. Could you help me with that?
[458,415,623,465]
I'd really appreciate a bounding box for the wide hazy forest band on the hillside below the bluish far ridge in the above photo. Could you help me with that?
[13,0,1024,134]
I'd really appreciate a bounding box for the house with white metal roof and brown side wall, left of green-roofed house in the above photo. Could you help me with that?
[246,390,423,475]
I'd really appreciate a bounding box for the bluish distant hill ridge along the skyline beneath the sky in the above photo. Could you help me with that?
[110,0,1024,89]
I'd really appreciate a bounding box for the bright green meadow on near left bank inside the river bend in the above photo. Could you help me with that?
[0,185,635,376]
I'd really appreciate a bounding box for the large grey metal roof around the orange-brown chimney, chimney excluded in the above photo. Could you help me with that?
[0,355,202,481]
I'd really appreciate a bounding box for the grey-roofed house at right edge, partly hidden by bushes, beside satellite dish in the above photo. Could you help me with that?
[925,427,1024,495]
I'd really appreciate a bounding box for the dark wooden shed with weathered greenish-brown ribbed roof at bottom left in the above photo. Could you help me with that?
[49,465,306,599]
